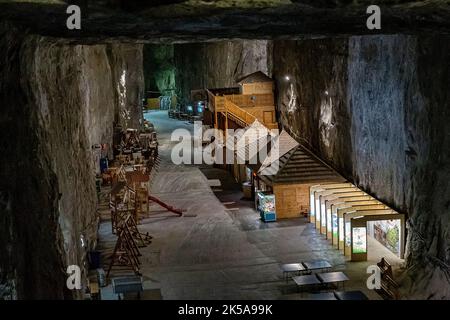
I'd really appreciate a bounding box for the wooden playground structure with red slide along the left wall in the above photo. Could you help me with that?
[102,125,183,277]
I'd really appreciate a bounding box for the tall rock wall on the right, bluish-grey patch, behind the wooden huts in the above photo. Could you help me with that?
[274,35,450,299]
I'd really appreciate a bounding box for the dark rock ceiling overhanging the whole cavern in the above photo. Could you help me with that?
[0,0,450,43]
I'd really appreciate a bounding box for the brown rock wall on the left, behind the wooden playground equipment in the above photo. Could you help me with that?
[0,23,143,299]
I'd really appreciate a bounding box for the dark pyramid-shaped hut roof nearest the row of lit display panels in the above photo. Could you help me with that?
[259,140,346,185]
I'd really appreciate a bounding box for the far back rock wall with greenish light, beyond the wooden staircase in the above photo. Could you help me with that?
[174,40,272,102]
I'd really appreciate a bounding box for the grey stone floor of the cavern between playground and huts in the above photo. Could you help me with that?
[99,111,388,300]
